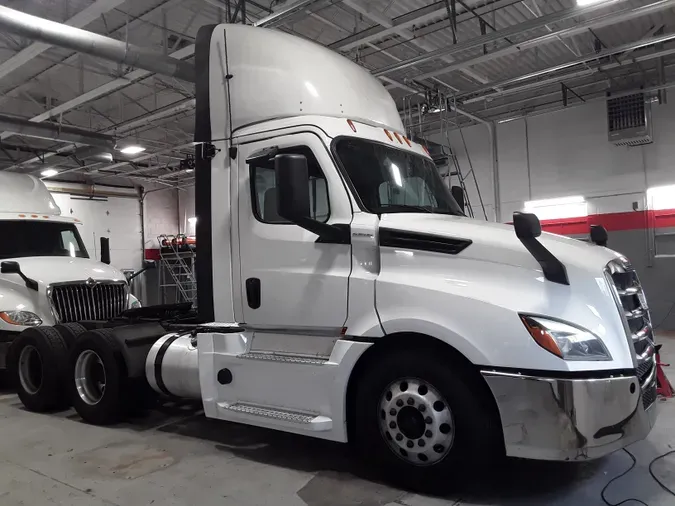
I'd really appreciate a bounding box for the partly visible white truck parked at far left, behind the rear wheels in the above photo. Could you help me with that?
[0,172,135,368]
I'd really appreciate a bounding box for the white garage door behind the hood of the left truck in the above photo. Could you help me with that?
[52,193,143,270]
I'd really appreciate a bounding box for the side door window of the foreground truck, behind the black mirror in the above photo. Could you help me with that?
[250,147,330,224]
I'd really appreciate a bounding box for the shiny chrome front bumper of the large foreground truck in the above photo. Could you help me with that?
[481,371,657,460]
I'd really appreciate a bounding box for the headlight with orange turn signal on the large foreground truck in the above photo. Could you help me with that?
[520,315,612,360]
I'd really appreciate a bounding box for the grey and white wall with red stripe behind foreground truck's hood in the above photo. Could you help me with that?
[440,102,675,329]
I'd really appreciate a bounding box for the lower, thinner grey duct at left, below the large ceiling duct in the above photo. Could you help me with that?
[0,114,115,151]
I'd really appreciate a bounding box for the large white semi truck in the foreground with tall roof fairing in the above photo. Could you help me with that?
[7,25,656,486]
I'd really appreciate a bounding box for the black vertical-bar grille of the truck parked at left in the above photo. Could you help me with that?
[51,283,127,323]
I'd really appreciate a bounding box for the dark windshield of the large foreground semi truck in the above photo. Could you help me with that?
[335,137,464,216]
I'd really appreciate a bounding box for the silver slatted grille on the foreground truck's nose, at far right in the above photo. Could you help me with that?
[608,258,656,409]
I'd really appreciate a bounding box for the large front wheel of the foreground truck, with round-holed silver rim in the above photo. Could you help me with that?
[349,350,503,492]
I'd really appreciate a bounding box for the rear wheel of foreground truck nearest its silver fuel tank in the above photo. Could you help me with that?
[67,329,130,425]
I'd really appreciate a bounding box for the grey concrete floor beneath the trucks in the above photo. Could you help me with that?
[0,338,675,506]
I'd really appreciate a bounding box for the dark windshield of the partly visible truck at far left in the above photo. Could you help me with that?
[0,220,89,259]
